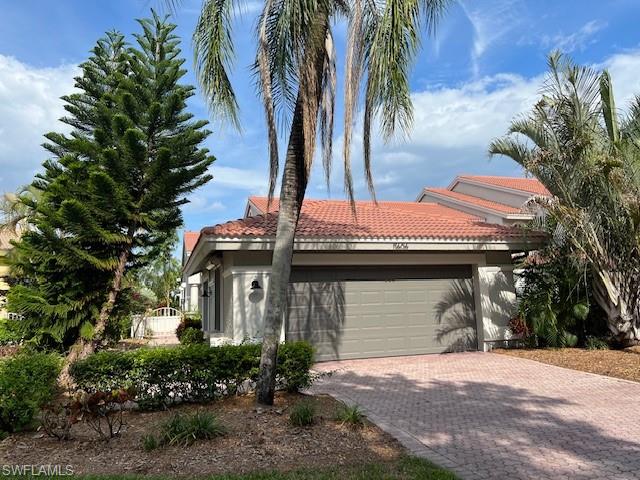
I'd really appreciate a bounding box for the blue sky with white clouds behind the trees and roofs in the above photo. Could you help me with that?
[0,0,640,236]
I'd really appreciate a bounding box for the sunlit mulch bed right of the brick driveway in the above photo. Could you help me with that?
[493,347,640,382]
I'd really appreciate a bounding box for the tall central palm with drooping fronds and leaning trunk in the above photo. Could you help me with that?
[185,0,449,405]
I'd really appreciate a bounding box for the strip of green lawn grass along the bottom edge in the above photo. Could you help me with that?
[12,457,458,480]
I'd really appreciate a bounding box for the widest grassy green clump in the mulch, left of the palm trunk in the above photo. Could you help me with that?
[158,411,227,446]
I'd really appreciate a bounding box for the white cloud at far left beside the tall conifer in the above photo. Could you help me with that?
[0,55,79,191]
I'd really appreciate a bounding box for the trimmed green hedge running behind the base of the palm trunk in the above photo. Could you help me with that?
[70,342,313,410]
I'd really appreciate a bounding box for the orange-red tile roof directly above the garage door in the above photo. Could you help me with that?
[202,197,531,240]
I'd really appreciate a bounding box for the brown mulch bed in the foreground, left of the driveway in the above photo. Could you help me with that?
[0,393,405,476]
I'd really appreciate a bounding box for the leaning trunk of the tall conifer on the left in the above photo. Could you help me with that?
[58,238,132,389]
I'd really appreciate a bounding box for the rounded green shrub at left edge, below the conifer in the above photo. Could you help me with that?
[0,350,61,432]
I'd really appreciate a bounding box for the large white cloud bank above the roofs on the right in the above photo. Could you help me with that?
[311,50,640,199]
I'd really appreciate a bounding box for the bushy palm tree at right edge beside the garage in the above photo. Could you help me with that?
[489,53,640,345]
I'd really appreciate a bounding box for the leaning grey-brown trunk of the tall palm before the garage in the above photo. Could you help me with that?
[256,17,328,405]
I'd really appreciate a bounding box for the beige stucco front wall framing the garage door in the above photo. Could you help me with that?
[211,252,515,350]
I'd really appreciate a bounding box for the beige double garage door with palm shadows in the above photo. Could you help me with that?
[287,278,477,360]
